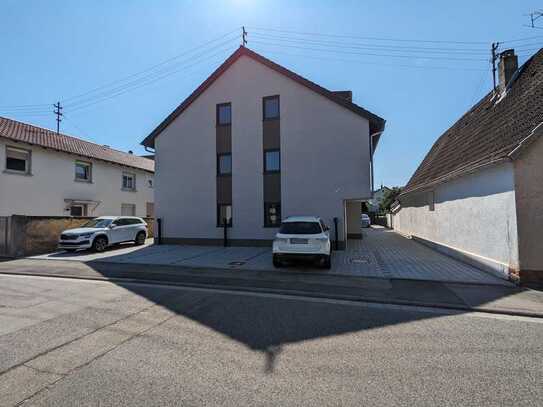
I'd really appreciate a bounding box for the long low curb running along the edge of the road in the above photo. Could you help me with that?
[0,271,543,319]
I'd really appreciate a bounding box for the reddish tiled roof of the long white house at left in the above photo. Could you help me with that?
[0,117,155,172]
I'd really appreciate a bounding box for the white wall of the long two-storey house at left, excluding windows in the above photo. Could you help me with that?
[0,138,154,216]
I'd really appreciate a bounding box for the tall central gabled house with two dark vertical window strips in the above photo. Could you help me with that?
[142,47,385,246]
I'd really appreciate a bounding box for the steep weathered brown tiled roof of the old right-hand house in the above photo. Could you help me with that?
[402,49,543,195]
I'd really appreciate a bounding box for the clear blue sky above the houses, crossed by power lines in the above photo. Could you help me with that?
[0,0,543,185]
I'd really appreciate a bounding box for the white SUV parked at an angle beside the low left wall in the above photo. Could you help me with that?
[58,216,147,252]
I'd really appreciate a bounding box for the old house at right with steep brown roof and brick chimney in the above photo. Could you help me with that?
[393,50,543,282]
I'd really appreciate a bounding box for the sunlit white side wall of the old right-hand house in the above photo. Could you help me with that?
[393,162,519,277]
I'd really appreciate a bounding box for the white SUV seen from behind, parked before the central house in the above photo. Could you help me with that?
[273,216,332,269]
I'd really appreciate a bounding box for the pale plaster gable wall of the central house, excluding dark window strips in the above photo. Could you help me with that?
[155,56,371,245]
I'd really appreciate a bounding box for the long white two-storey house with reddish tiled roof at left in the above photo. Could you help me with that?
[0,117,154,216]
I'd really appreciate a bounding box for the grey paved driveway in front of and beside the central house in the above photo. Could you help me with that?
[32,227,510,285]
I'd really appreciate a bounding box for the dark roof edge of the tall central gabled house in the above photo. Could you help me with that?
[141,46,385,147]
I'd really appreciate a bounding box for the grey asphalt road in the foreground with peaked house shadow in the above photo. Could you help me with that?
[0,276,543,406]
